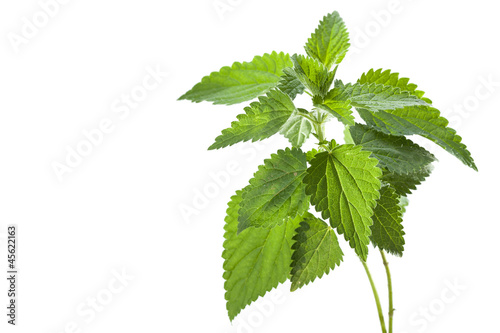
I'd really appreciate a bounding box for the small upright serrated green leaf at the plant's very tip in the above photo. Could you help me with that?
[305,12,350,68]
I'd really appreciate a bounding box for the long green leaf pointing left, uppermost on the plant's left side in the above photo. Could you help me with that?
[179,52,293,105]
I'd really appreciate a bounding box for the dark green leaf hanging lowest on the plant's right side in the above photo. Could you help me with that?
[370,186,405,256]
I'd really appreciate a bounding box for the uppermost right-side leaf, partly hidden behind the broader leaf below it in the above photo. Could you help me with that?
[358,69,432,104]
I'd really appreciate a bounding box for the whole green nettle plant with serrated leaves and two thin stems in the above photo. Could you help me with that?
[180,12,477,332]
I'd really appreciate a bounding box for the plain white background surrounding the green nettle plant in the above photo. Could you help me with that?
[0,0,500,333]
